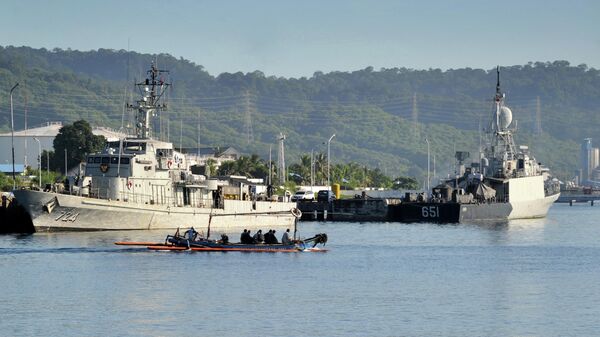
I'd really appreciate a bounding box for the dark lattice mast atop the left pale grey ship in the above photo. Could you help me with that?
[127,63,171,139]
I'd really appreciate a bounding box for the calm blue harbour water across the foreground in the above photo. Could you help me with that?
[0,201,600,336]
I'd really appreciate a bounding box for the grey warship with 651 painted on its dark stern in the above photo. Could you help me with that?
[388,67,560,223]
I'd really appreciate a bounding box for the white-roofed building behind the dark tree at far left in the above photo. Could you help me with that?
[0,122,125,168]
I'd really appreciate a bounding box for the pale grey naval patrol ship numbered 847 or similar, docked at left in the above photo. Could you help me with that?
[13,64,298,231]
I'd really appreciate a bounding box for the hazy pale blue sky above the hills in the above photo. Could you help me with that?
[0,0,600,77]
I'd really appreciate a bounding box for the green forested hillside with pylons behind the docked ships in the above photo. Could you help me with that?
[0,47,600,181]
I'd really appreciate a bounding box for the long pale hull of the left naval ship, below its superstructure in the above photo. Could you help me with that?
[13,190,296,232]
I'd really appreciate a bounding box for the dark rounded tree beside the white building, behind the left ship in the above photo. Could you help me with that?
[53,120,106,170]
